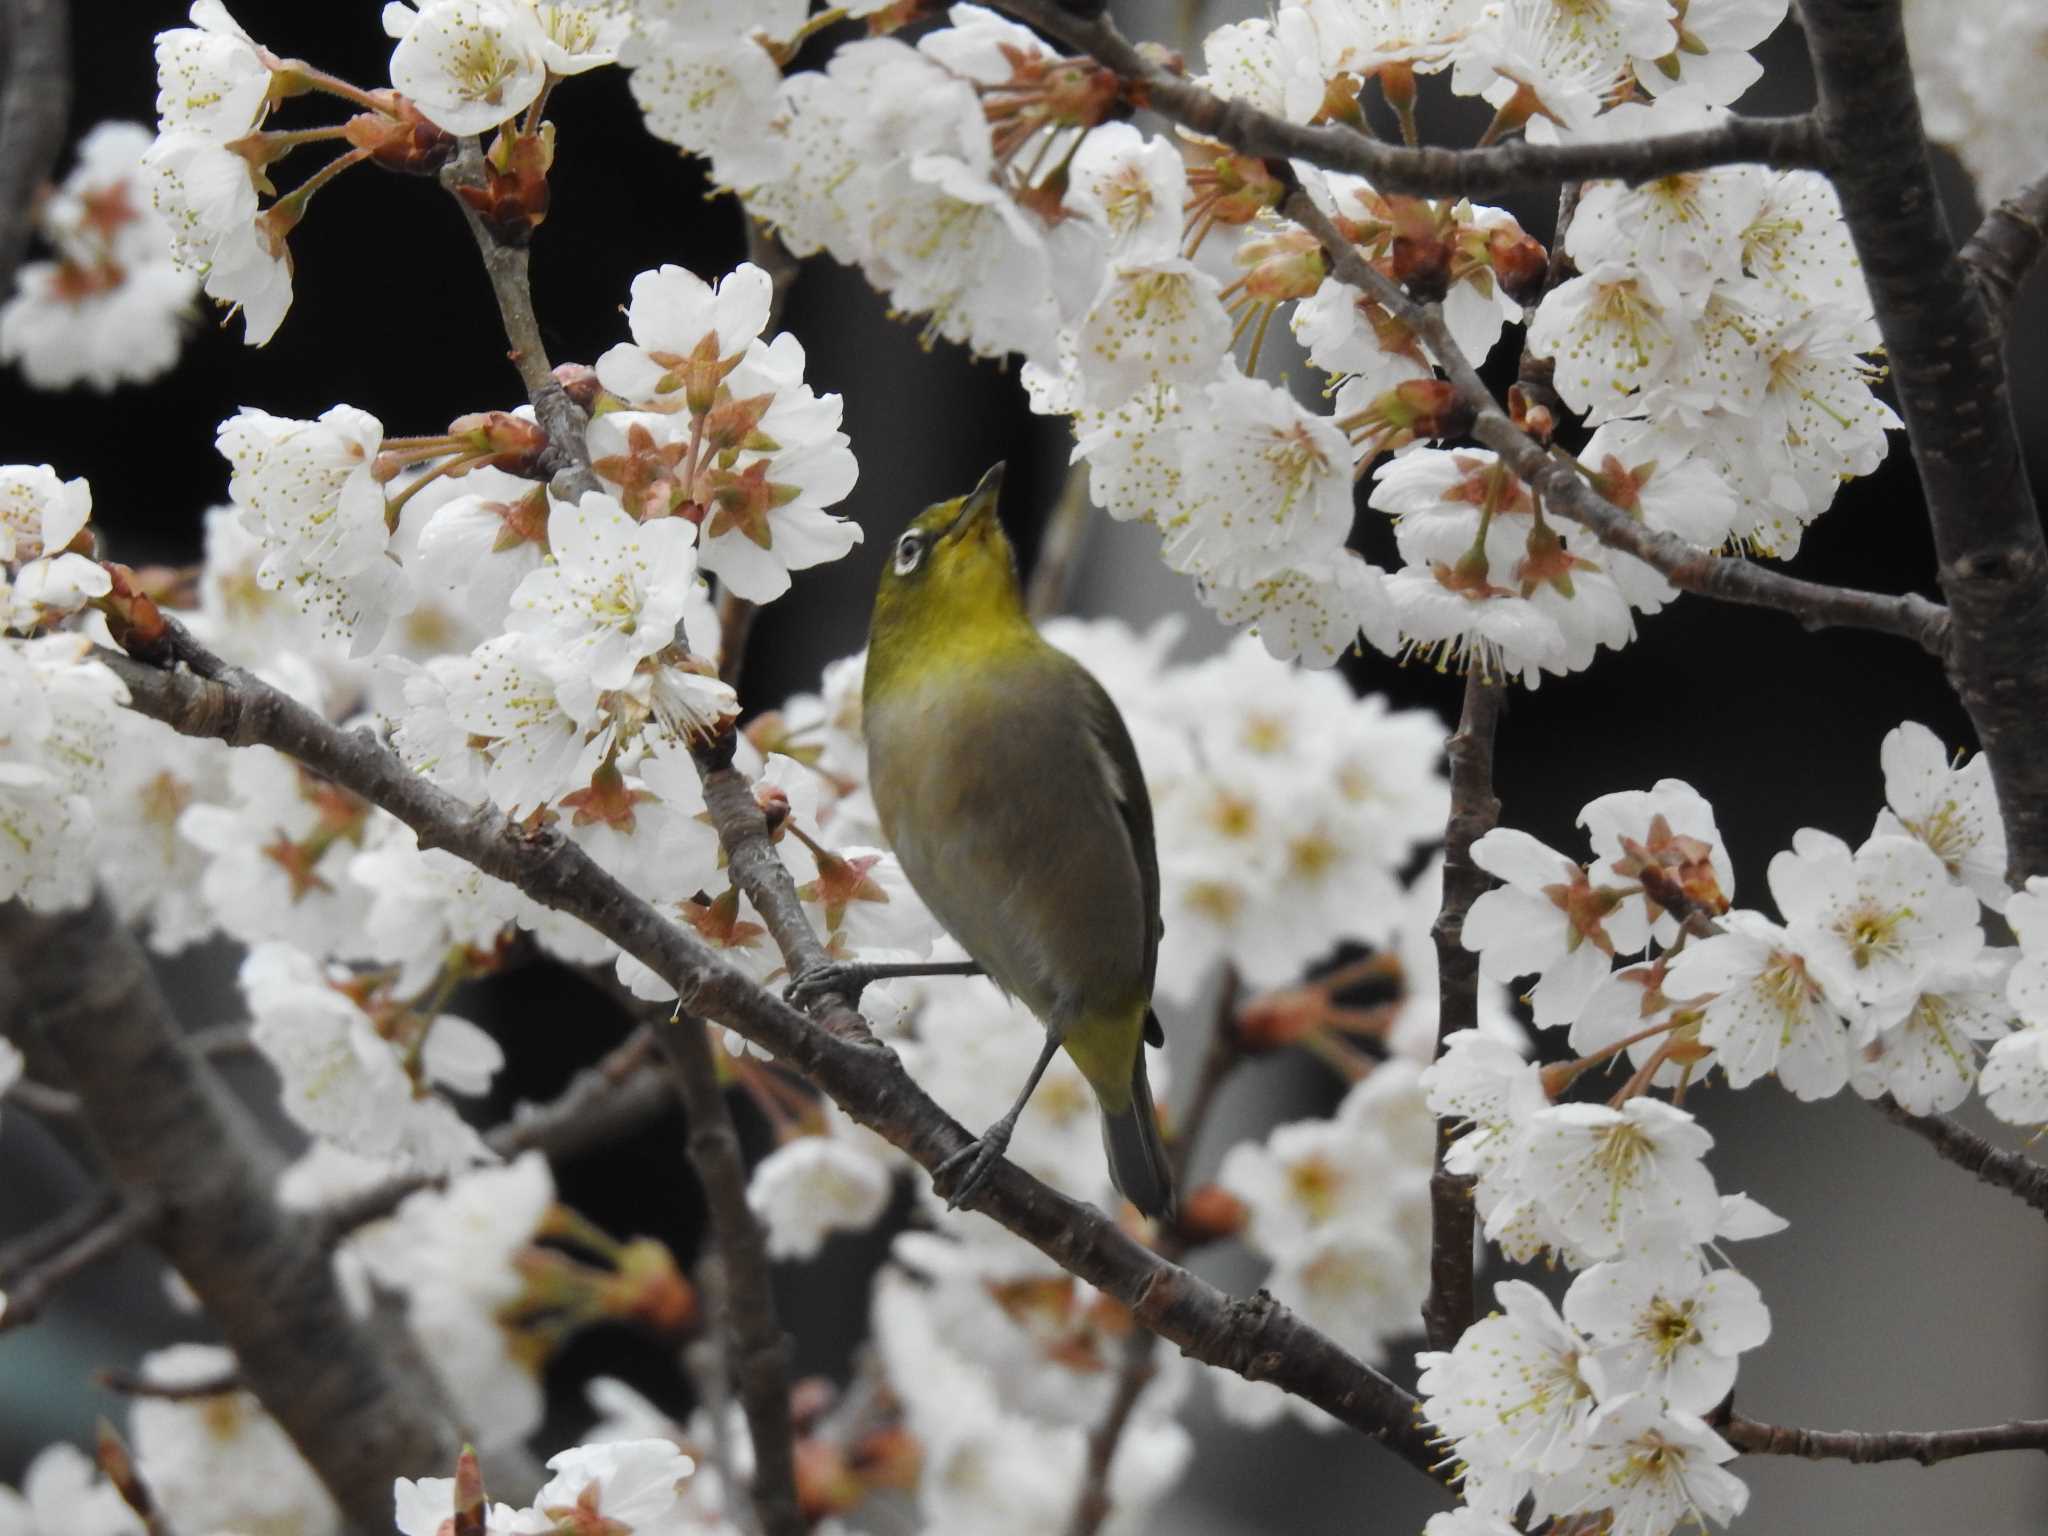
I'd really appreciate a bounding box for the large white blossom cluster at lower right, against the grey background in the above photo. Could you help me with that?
[1421,723,2048,1536]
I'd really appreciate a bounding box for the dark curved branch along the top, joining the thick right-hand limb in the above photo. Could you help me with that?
[991,0,1823,197]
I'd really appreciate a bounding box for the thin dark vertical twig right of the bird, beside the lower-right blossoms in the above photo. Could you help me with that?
[1421,668,1505,1350]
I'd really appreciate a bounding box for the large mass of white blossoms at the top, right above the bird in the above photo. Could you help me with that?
[585,0,1896,684]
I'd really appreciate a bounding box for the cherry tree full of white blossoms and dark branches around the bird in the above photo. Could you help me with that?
[0,0,2048,1536]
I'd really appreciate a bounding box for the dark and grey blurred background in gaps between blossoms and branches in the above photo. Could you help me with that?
[0,0,2048,1536]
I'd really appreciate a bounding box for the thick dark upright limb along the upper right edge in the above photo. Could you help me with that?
[1800,0,2048,881]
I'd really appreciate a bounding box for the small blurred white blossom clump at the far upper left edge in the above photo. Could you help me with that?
[0,123,199,391]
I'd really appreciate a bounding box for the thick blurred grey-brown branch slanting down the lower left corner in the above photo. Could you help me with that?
[0,897,475,1530]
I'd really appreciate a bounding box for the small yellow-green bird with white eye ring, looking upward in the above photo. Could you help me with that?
[862,465,1174,1217]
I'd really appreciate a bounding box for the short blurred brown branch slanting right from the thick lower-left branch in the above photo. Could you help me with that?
[319,1028,676,1245]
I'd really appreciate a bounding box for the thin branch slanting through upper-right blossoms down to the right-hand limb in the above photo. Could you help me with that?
[1280,186,1948,655]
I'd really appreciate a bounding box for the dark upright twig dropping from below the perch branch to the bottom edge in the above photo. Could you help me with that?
[655,1014,807,1536]
